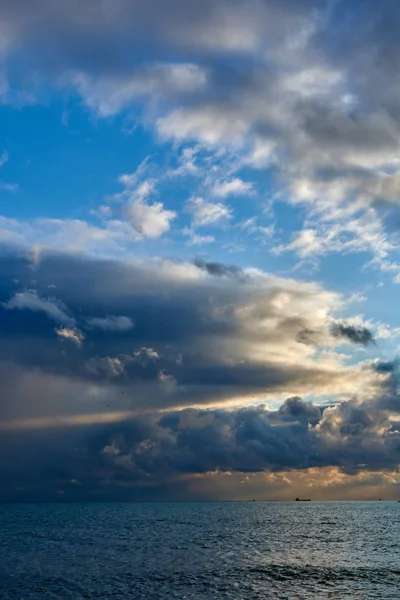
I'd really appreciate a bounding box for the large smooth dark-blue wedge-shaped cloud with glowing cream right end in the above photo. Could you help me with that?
[0,247,354,405]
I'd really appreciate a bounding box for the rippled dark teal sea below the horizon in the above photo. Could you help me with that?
[0,502,400,600]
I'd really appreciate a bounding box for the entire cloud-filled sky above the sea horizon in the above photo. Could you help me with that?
[0,0,400,502]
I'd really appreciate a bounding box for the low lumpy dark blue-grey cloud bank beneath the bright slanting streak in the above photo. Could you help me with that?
[0,398,400,499]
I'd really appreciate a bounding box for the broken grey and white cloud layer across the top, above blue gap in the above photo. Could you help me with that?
[2,0,400,274]
